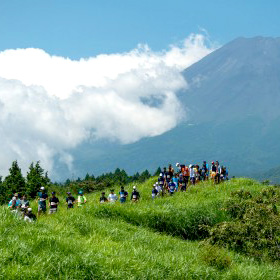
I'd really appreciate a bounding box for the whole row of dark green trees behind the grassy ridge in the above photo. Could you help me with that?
[0,161,160,204]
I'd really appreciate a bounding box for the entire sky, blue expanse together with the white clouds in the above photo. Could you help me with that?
[0,0,280,178]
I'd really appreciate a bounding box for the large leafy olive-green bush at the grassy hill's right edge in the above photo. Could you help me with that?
[208,188,280,261]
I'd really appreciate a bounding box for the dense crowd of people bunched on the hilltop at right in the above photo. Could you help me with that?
[152,161,229,198]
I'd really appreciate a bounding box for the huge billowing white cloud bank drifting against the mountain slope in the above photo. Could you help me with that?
[0,35,215,178]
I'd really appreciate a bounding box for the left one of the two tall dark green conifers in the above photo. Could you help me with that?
[3,160,26,196]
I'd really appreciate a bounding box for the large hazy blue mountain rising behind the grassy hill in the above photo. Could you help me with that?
[64,37,280,179]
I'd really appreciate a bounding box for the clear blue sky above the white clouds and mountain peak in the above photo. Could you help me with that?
[0,0,280,59]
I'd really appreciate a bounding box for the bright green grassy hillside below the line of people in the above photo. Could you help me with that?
[0,178,280,279]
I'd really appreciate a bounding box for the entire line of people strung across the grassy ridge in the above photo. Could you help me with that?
[8,161,229,222]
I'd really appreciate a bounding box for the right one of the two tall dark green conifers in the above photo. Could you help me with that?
[26,161,50,198]
